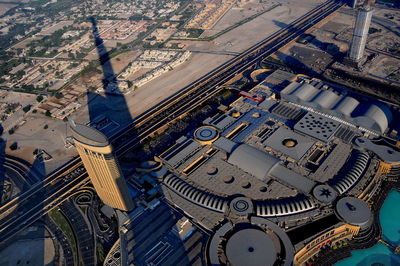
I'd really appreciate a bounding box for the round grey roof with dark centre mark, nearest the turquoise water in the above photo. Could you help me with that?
[336,197,372,228]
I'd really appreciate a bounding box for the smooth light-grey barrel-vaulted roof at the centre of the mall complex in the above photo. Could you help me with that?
[228,144,280,180]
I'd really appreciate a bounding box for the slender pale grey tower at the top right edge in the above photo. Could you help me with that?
[349,1,373,63]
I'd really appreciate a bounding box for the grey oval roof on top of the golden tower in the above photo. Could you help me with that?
[71,124,109,147]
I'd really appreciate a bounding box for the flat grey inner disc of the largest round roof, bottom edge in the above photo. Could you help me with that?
[226,228,280,266]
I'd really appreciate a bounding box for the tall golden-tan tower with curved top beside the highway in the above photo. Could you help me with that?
[71,123,134,211]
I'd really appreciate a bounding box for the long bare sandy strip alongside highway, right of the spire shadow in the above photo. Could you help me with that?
[120,1,320,117]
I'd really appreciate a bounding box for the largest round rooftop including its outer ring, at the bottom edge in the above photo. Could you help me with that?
[208,218,294,266]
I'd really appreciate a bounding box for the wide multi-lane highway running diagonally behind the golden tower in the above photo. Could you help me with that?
[0,1,342,245]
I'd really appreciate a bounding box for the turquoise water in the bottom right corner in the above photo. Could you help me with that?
[335,190,400,266]
